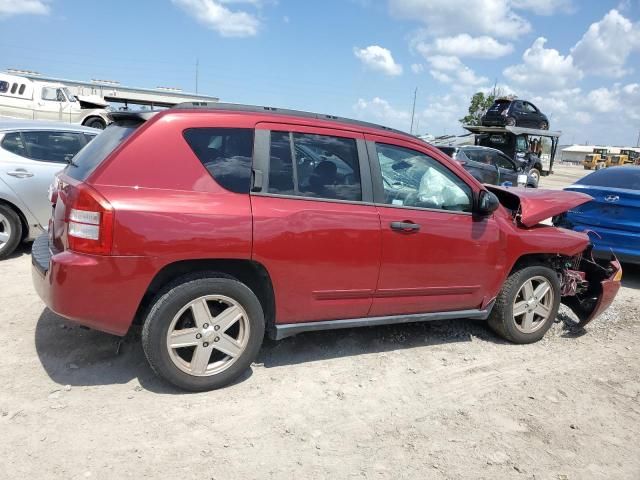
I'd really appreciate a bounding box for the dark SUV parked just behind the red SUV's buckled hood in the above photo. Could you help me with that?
[436,145,538,188]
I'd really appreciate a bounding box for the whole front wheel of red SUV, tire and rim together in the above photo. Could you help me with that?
[488,265,560,344]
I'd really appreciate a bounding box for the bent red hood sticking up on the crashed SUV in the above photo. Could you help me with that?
[485,185,592,227]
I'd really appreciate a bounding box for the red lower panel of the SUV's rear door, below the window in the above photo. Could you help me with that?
[251,195,380,323]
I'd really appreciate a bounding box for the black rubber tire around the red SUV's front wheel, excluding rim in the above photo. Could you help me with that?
[502,266,560,343]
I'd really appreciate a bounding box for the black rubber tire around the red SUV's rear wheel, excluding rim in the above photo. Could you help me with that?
[142,277,265,391]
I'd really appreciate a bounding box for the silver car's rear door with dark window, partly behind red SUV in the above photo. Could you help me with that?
[0,130,86,228]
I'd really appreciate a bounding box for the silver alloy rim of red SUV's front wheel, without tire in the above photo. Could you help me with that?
[513,276,554,333]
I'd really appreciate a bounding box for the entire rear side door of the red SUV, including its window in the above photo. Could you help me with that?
[251,123,381,324]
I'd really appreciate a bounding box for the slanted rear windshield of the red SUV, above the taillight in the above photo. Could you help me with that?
[65,124,136,181]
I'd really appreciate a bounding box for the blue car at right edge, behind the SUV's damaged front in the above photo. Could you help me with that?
[554,166,640,264]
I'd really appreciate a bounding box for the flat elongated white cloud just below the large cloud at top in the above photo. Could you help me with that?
[413,33,513,58]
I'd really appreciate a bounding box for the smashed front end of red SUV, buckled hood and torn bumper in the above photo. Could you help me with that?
[487,186,622,327]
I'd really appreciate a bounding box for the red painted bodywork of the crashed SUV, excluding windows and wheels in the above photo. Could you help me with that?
[33,110,615,335]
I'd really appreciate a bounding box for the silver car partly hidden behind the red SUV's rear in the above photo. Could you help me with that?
[0,119,100,259]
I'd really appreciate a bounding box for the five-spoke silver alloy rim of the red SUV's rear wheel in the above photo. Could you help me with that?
[167,295,250,377]
